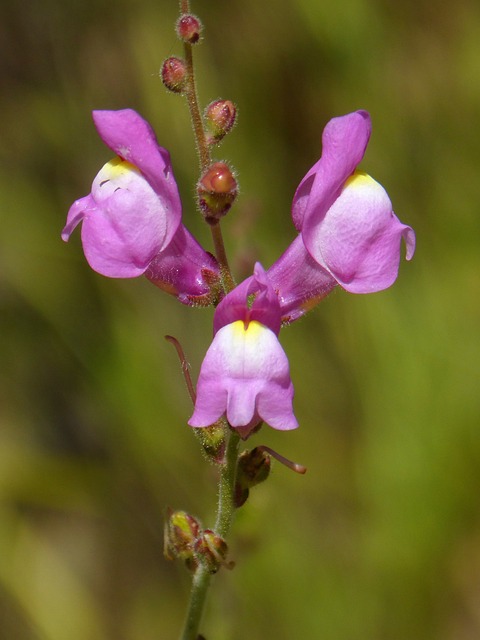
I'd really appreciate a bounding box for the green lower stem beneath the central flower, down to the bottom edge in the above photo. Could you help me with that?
[181,430,240,640]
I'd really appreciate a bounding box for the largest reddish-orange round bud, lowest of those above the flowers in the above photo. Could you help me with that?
[197,162,237,224]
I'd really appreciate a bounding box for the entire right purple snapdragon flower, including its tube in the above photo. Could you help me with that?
[268,111,415,321]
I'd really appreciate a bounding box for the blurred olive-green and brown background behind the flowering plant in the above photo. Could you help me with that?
[0,0,480,640]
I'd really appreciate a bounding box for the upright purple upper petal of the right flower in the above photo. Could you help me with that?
[292,111,371,231]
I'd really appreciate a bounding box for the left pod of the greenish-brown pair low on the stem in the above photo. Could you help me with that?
[163,509,200,570]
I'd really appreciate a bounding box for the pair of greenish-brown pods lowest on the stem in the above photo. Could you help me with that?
[164,509,234,573]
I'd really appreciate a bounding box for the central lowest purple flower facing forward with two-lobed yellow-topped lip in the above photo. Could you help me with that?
[189,263,298,438]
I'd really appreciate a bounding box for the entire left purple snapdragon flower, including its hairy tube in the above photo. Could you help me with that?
[62,109,218,303]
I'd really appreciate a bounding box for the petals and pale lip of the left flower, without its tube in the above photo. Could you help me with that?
[62,109,186,278]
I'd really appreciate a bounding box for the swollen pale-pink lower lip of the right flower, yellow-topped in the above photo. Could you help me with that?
[302,172,415,293]
